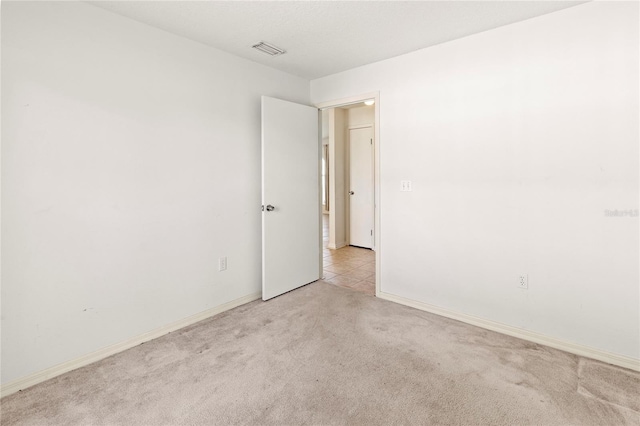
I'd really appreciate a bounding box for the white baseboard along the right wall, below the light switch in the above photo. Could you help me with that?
[376,292,640,371]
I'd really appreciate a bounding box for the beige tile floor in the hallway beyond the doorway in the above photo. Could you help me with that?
[322,215,376,296]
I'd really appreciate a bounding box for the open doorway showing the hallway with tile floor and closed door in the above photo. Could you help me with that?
[319,94,379,295]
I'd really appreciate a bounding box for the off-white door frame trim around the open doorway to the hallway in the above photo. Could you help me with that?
[313,91,382,297]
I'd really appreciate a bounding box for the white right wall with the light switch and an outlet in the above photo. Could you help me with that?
[311,2,640,359]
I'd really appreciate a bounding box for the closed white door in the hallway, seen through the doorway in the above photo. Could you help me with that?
[349,127,374,248]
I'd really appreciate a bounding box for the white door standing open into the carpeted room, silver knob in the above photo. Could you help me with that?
[262,96,322,300]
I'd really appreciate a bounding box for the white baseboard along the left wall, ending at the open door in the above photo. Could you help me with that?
[0,293,262,397]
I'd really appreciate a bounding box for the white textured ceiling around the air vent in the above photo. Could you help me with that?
[88,0,583,79]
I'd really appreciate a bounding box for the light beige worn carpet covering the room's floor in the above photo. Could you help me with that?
[1,282,640,425]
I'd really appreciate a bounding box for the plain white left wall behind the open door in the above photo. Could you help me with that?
[2,2,309,383]
